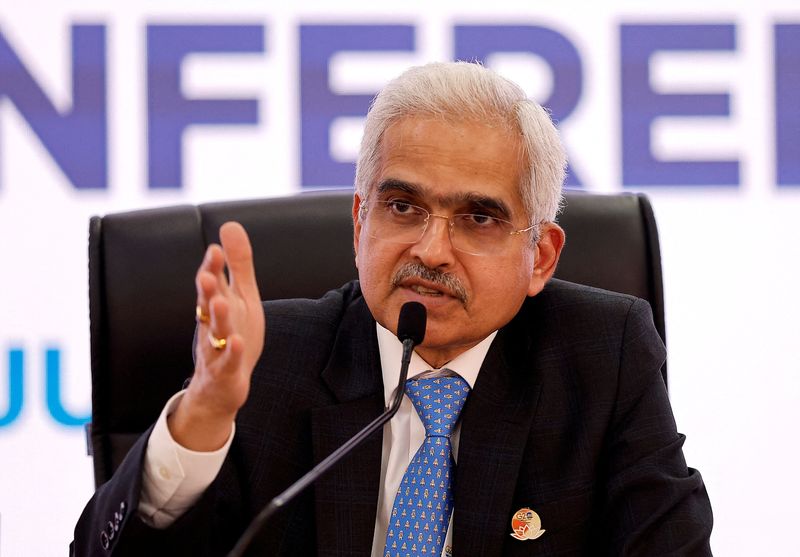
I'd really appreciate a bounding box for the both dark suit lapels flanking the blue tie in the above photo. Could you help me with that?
[311,298,541,557]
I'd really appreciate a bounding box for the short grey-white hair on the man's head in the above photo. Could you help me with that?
[355,62,567,230]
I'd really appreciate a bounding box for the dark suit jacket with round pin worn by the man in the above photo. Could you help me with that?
[74,280,712,557]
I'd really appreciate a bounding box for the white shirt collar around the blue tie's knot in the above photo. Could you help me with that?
[375,322,497,405]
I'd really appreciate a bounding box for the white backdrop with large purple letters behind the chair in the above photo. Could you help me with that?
[0,0,800,557]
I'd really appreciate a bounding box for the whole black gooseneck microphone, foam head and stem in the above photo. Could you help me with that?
[228,302,427,557]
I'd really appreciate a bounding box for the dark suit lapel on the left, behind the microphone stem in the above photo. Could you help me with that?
[311,299,384,556]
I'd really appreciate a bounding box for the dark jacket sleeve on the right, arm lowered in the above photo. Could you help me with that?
[604,300,713,557]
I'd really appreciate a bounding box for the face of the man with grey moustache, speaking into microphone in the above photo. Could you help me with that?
[353,117,563,367]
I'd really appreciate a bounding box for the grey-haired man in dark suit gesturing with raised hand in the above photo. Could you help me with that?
[74,63,711,556]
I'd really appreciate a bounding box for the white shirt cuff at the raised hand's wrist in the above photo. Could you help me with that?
[139,391,236,528]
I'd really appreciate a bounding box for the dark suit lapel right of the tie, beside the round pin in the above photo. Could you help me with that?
[453,322,541,557]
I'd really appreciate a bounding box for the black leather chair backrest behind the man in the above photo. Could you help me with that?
[89,191,666,485]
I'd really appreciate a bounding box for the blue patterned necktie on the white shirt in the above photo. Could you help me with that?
[383,376,469,557]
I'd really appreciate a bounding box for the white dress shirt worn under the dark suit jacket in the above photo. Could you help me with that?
[139,325,497,557]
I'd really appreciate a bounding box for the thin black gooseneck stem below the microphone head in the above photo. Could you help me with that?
[223,338,414,557]
